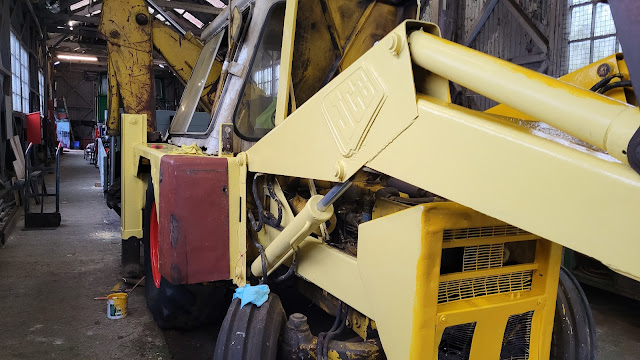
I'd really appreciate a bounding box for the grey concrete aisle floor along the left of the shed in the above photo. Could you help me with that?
[0,151,171,360]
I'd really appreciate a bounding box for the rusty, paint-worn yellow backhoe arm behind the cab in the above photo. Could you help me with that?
[99,0,222,134]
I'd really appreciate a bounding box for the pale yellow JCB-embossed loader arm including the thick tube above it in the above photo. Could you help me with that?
[246,22,640,279]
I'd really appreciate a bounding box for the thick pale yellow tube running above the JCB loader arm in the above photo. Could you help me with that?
[409,31,640,171]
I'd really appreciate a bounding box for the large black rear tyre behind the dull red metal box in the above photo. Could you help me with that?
[143,179,230,329]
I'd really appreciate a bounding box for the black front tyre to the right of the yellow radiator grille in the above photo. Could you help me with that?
[549,267,597,360]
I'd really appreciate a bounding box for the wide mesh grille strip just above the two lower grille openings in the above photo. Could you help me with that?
[438,270,533,304]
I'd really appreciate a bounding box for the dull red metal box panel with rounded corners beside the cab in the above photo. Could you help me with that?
[158,155,230,284]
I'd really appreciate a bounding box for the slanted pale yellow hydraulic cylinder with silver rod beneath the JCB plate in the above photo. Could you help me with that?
[251,192,332,276]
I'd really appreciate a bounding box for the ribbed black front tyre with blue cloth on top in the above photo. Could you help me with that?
[213,293,286,360]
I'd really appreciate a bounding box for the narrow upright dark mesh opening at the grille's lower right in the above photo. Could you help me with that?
[500,310,533,360]
